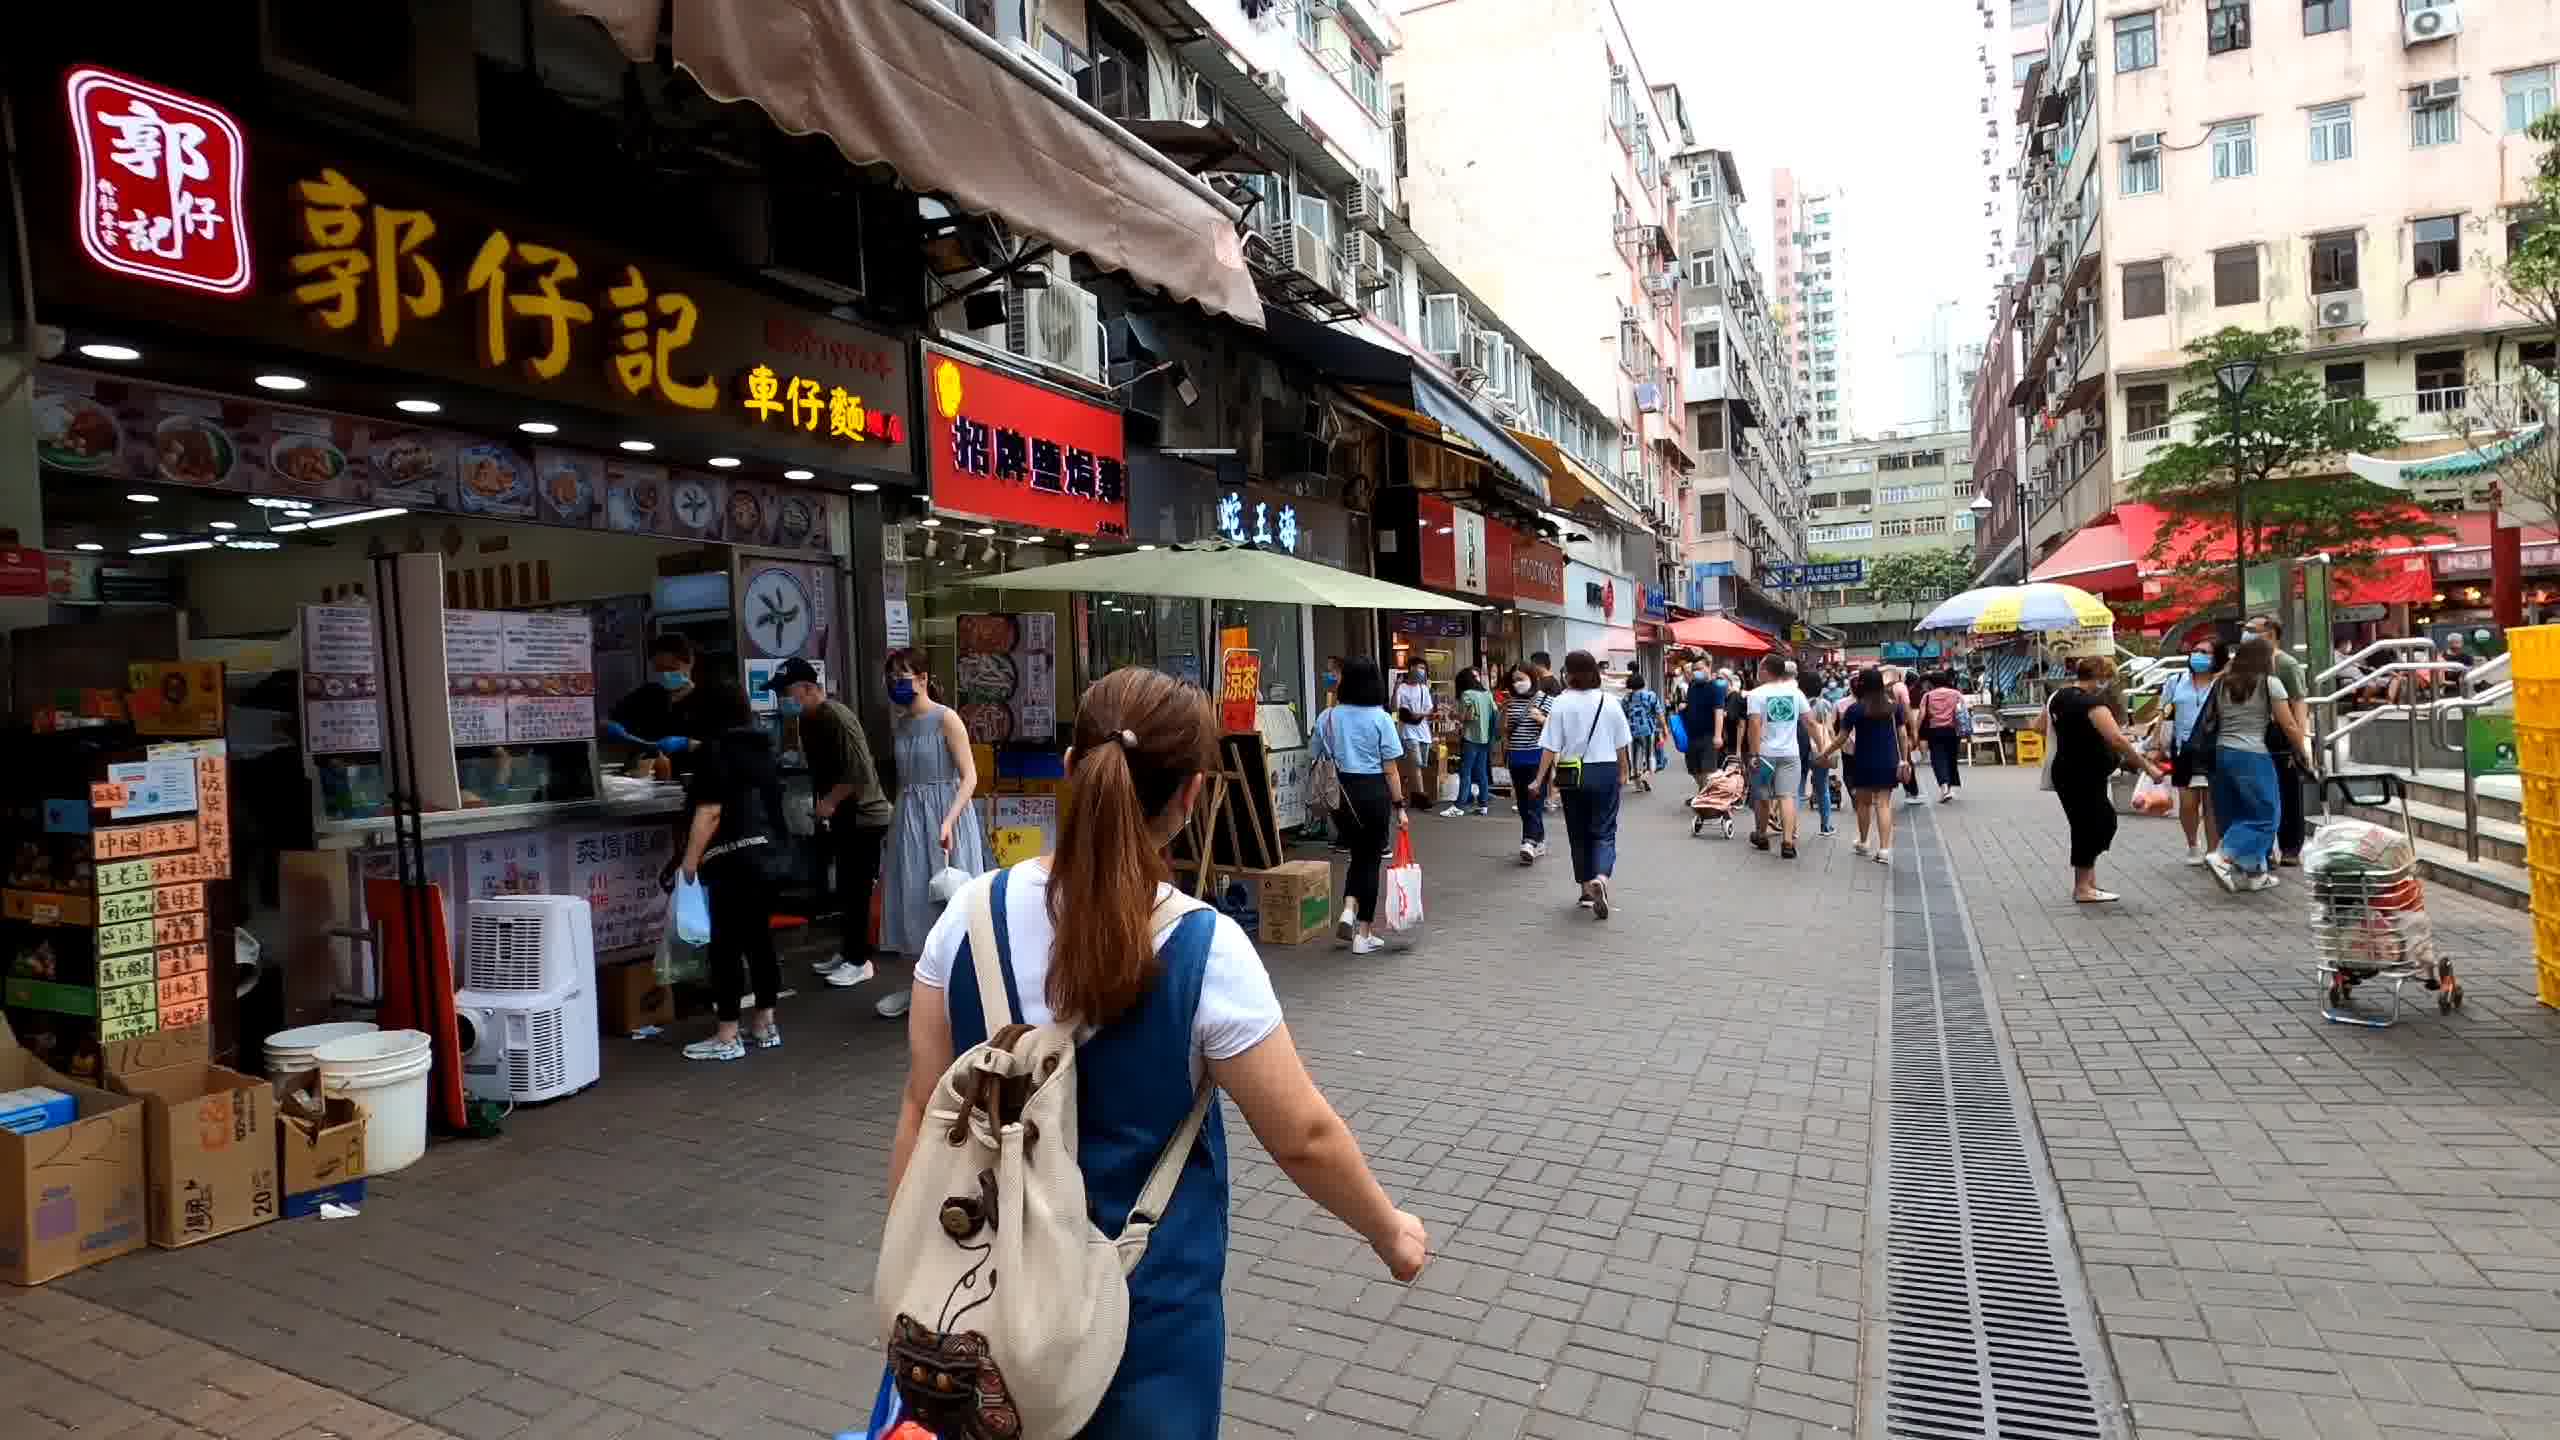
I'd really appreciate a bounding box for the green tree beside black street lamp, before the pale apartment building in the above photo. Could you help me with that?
[2117,325,2447,612]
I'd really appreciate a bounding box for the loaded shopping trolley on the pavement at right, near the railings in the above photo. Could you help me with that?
[2301,771,2463,1030]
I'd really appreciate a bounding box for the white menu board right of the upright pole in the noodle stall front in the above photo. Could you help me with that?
[445,610,596,746]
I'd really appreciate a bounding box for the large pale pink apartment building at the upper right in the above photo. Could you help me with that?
[2012,0,2560,571]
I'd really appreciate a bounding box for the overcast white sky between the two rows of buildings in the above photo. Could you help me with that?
[1618,0,2015,430]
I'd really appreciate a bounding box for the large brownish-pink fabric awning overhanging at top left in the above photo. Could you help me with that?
[553,0,1262,325]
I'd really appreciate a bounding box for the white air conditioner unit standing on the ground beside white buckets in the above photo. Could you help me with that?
[453,894,599,1104]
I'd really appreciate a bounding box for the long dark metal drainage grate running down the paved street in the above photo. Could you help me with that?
[1882,810,2125,1440]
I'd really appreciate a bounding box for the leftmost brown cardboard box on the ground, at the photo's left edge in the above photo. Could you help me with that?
[0,1020,148,1286]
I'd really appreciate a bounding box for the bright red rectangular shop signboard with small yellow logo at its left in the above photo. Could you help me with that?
[924,346,1129,536]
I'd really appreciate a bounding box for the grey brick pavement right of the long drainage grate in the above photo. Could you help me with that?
[1930,769,2560,1440]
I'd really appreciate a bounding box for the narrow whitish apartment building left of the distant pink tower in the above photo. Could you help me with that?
[1672,149,1805,610]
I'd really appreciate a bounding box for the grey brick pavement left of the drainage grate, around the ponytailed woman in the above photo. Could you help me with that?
[15,794,1887,1440]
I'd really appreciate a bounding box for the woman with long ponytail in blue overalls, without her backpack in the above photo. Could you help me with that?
[888,669,1426,1440]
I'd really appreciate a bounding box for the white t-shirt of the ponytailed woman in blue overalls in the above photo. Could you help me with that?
[916,861,1280,1084]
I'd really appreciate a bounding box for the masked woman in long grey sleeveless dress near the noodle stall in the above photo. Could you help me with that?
[878,651,993,1014]
